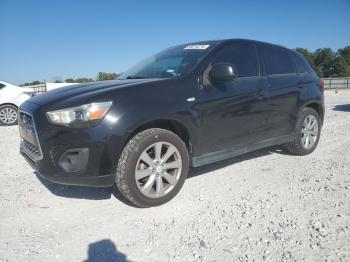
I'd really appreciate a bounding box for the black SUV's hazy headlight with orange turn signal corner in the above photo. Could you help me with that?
[46,102,112,128]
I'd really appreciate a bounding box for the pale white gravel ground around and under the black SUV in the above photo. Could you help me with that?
[0,91,350,261]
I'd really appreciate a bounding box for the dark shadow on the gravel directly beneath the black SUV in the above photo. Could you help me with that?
[36,146,289,207]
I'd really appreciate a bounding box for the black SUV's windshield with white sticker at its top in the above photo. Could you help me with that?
[118,43,214,80]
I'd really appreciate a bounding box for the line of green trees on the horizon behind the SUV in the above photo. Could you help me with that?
[21,46,350,86]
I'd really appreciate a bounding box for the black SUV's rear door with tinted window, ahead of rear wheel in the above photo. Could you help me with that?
[258,45,302,138]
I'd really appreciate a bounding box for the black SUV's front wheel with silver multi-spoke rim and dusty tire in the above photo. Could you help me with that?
[115,128,189,207]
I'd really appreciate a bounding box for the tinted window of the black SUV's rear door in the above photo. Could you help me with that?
[262,46,295,75]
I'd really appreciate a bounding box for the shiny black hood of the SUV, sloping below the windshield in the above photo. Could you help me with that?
[29,78,164,105]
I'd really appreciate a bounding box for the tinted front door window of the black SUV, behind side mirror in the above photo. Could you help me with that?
[213,43,259,77]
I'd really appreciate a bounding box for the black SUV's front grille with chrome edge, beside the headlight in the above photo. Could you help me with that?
[18,111,42,161]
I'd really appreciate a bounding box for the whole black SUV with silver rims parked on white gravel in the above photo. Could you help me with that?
[19,39,324,207]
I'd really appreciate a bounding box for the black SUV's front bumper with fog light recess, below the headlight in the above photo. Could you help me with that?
[19,102,123,187]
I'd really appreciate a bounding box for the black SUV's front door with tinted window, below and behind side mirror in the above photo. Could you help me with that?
[198,42,267,152]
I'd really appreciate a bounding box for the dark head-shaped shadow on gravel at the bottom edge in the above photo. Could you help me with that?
[84,239,129,262]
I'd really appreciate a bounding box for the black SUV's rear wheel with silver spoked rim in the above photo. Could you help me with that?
[287,107,322,156]
